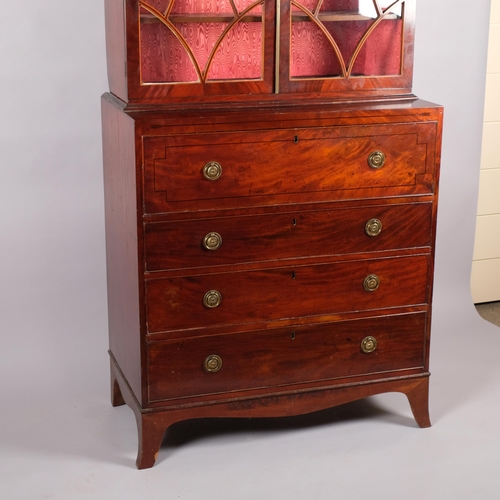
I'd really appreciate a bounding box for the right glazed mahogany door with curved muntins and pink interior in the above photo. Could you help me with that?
[279,0,415,96]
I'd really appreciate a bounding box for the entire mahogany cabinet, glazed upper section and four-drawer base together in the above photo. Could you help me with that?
[102,0,443,469]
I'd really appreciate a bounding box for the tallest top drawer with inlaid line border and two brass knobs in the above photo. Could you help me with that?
[144,123,436,213]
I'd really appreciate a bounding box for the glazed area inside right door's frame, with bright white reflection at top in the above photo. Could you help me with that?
[290,0,403,78]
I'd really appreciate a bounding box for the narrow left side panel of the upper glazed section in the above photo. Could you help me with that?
[104,0,128,101]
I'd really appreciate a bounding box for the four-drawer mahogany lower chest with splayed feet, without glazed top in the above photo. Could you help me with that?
[102,94,442,468]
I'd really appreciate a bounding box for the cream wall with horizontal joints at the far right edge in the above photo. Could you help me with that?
[471,0,500,303]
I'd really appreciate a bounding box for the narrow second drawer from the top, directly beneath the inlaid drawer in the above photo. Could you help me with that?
[145,203,432,271]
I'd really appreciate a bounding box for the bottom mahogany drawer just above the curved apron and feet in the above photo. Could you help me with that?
[147,313,426,402]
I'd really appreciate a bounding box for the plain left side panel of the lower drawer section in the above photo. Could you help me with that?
[102,98,141,401]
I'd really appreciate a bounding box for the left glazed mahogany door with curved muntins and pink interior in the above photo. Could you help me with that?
[131,0,276,98]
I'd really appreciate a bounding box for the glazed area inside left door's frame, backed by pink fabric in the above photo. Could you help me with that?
[140,0,263,83]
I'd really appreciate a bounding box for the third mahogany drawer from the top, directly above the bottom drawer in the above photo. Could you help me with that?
[146,255,430,333]
